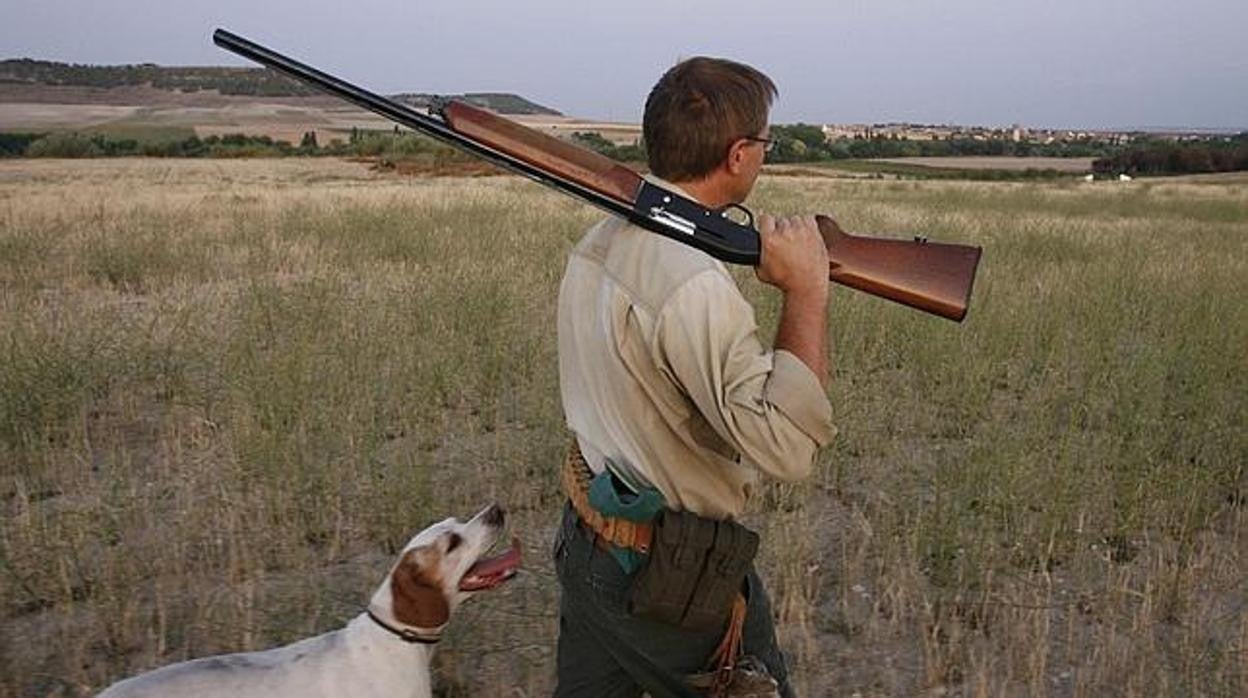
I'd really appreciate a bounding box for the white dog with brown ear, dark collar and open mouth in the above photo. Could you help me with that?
[100,506,520,698]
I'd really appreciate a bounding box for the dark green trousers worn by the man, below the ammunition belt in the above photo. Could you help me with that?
[554,506,792,698]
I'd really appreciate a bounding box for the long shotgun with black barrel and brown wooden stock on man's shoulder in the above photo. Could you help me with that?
[212,29,982,321]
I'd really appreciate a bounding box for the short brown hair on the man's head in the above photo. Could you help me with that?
[641,56,776,182]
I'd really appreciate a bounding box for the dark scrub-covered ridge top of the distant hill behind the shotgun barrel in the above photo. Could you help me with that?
[0,59,559,115]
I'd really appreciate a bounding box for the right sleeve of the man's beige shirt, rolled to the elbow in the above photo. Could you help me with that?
[651,270,836,481]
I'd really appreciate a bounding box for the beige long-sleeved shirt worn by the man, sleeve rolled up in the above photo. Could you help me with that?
[558,179,836,518]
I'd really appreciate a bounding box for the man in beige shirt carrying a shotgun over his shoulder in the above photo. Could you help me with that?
[555,57,835,697]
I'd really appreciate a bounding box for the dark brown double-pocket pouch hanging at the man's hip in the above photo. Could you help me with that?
[629,511,759,631]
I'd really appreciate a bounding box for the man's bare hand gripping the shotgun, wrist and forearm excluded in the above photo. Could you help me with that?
[754,214,827,297]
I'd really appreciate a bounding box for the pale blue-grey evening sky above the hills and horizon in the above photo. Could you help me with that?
[0,0,1248,130]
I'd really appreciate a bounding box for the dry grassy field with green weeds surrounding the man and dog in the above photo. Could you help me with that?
[0,159,1248,697]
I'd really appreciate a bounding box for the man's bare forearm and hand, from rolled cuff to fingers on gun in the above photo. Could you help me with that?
[754,215,827,386]
